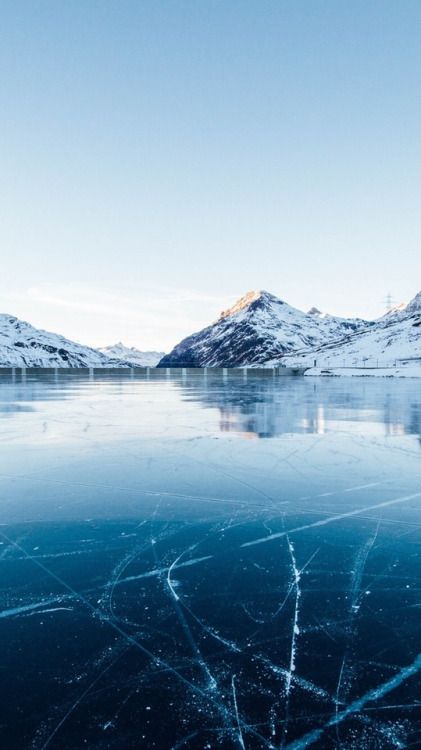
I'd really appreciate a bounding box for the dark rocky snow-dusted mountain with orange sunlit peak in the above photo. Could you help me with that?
[158,291,371,367]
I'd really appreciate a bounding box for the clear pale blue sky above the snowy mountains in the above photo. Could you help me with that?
[0,0,421,350]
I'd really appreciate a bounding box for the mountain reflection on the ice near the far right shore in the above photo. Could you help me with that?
[176,372,421,444]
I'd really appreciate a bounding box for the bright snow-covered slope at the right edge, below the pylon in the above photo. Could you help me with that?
[282,292,421,368]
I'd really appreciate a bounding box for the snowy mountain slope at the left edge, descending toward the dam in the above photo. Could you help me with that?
[0,314,129,367]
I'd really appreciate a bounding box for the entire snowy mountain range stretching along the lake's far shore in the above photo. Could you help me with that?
[4,291,421,370]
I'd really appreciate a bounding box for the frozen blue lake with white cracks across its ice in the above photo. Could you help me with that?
[0,370,421,750]
